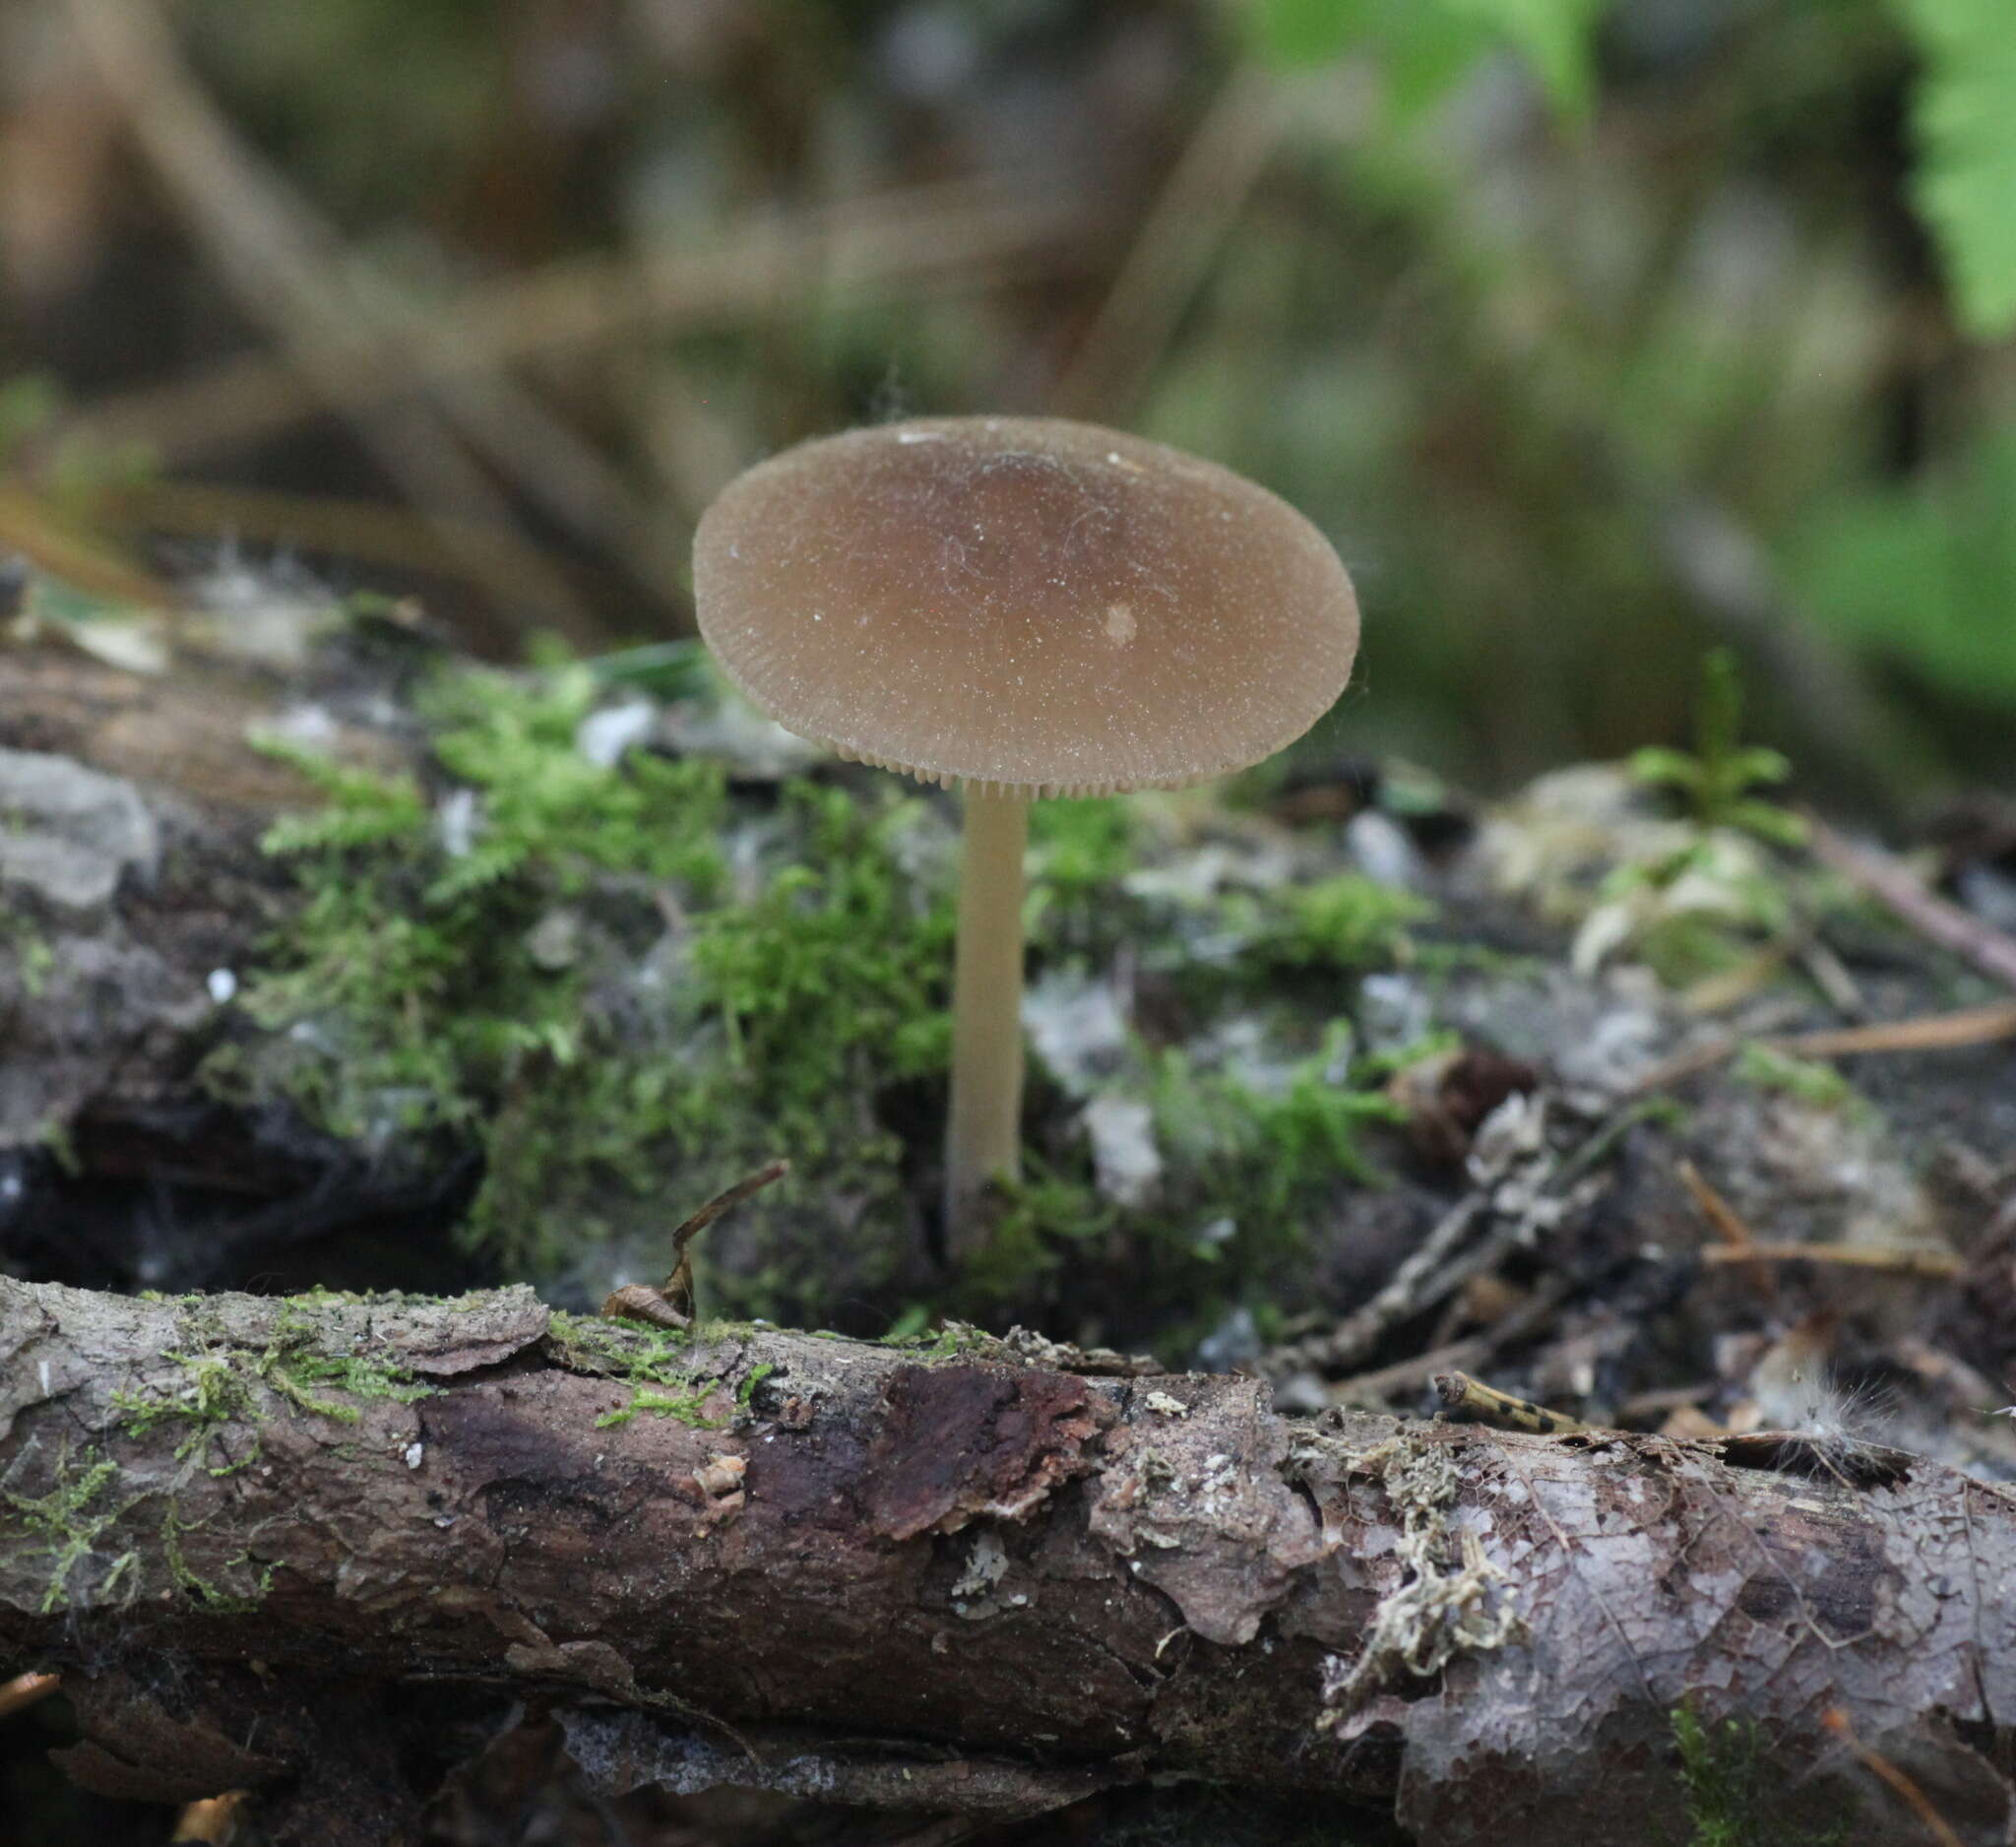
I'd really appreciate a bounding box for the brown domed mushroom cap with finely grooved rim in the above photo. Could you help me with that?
[694,417,1358,795]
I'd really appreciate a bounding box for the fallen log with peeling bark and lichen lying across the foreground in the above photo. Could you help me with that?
[0,1281,2016,1843]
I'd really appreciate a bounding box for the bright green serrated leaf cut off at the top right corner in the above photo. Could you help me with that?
[1891,0,2016,339]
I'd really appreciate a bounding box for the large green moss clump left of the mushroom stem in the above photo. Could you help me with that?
[206,662,952,1312]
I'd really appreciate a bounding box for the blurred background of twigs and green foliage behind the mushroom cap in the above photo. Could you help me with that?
[0,0,2016,810]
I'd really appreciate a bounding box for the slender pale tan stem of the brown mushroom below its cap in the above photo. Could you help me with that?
[946,789,1028,1258]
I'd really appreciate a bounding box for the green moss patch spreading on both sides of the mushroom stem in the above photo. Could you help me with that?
[210,662,1451,1338]
